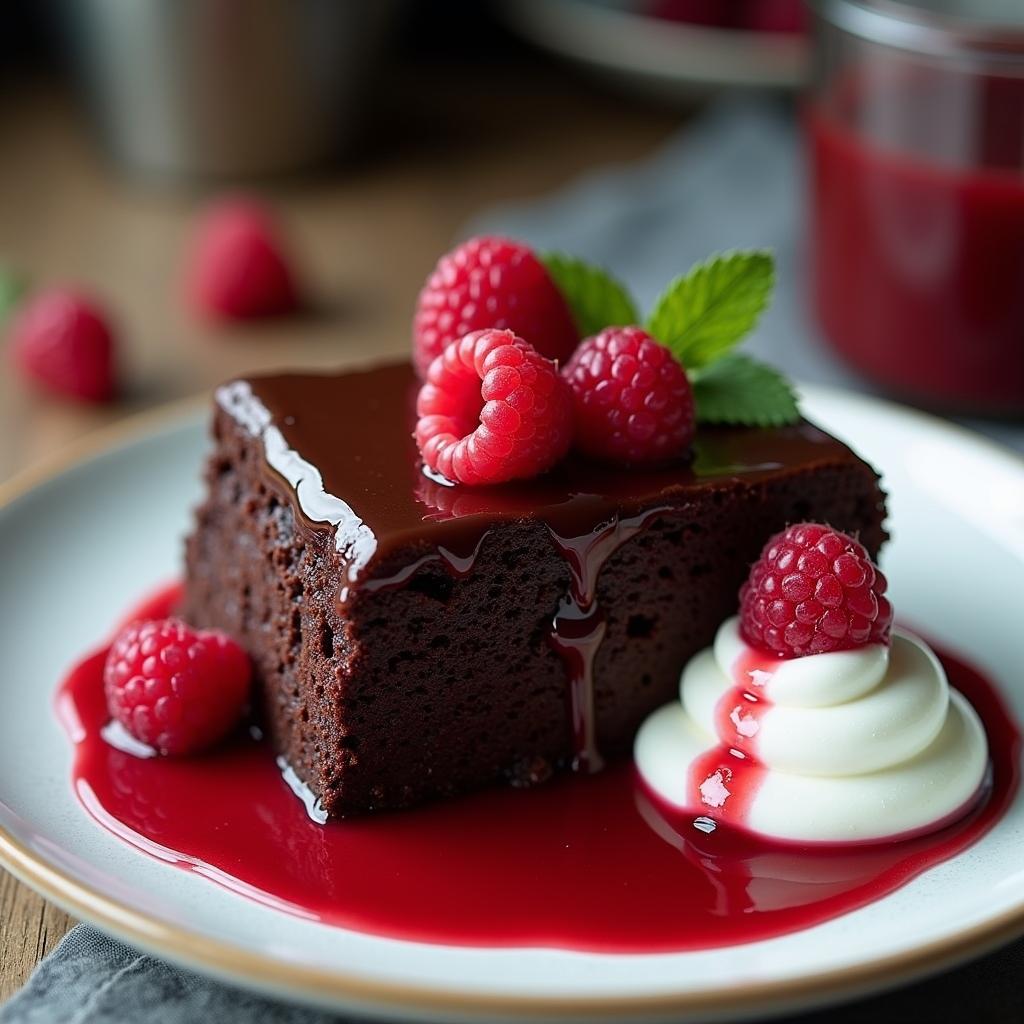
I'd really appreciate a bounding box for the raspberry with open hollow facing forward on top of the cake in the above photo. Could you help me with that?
[416,331,572,484]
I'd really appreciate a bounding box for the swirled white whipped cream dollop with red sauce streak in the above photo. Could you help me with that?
[635,618,988,842]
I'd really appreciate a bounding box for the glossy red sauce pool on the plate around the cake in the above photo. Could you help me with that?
[57,588,1020,953]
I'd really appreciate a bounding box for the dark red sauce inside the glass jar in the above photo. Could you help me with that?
[807,96,1024,415]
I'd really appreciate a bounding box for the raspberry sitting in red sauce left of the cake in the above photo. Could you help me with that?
[103,618,252,754]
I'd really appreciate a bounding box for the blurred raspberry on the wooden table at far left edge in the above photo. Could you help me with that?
[11,289,115,401]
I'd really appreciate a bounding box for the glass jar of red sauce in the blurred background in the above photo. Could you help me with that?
[806,0,1024,417]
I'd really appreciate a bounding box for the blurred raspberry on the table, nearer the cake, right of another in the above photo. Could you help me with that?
[185,200,299,321]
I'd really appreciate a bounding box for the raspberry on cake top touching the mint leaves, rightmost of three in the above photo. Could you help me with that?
[562,327,693,462]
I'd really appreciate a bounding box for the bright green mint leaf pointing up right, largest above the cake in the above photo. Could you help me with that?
[647,250,775,370]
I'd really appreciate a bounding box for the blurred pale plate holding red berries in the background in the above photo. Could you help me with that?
[499,0,810,96]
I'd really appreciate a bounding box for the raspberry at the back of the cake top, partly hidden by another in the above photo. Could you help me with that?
[413,238,580,379]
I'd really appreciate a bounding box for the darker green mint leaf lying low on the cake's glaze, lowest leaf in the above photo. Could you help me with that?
[691,353,800,427]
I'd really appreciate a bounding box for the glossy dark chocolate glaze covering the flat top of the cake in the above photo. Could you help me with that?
[217,364,856,584]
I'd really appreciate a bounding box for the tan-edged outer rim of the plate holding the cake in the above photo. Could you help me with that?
[0,385,1024,1019]
